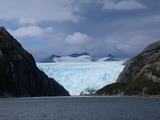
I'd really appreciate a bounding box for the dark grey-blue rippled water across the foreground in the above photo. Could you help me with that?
[0,97,160,120]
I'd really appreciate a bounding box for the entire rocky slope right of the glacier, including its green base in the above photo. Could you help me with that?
[96,41,160,95]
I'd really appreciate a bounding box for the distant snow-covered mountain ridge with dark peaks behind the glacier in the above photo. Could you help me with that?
[42,52,119,63]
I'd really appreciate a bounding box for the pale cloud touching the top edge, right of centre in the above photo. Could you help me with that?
[102,0,147,10]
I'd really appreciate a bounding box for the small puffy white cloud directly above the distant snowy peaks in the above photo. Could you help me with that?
[66,32,92,44]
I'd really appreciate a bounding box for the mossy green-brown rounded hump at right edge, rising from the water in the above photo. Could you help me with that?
[125,64,160,95]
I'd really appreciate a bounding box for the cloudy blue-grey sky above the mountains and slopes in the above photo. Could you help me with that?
[0,0,160,61]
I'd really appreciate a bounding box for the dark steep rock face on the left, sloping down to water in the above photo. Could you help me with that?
[0,27,69,97]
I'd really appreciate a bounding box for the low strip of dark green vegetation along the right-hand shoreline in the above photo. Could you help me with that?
[95,79,160,96]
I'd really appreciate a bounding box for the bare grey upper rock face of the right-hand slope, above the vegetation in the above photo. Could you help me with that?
[117,41,160,82]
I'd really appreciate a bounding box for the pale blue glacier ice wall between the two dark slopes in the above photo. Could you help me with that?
[37,61,124,95]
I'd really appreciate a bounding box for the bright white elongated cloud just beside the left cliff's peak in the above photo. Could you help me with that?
[9,25,54,37]
